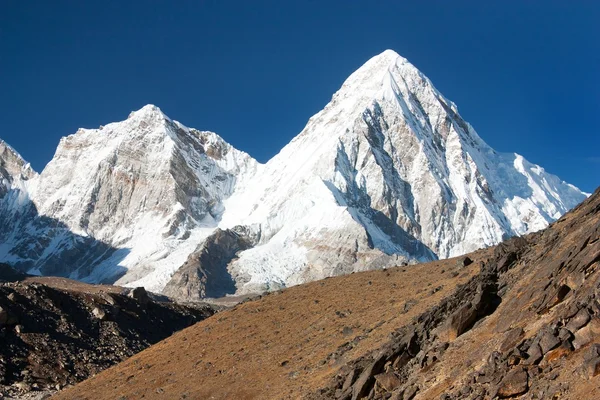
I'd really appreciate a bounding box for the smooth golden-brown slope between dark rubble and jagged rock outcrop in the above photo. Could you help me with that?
[56,250,488,399]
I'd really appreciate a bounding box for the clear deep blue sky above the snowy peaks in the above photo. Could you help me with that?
[0,0,600,191]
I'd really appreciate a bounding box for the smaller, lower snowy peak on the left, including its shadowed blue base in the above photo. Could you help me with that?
[3,105,257,290]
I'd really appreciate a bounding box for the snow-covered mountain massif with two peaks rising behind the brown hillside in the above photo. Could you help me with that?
[0,51,586,298]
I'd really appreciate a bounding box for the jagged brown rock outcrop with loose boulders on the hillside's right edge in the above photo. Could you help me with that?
[314,189,600,400]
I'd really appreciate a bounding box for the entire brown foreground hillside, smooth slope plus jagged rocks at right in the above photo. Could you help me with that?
[57,189,600,399]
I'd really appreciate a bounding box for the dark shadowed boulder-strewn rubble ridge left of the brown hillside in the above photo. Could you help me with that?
[0,276,214,398]
